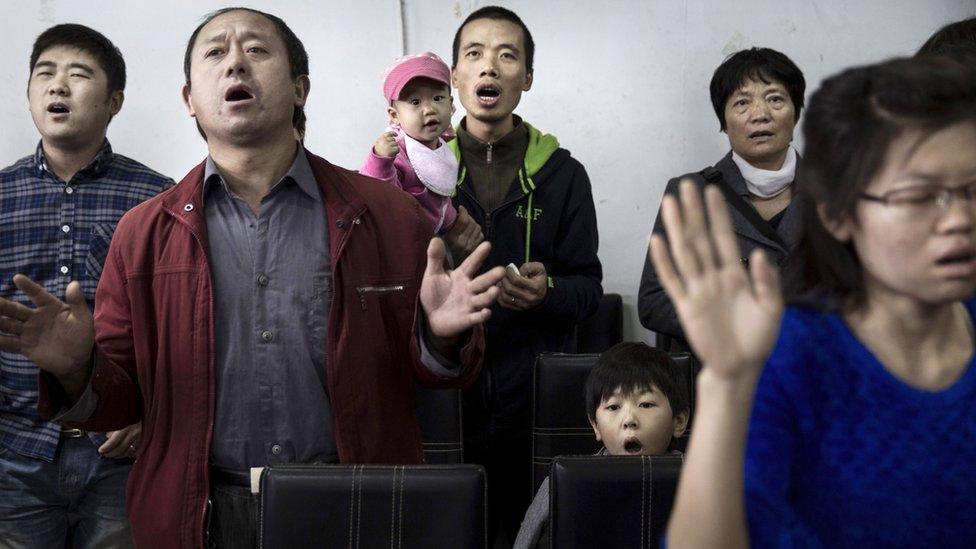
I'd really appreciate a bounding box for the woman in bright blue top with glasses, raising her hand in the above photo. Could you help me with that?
[651,54,976,547]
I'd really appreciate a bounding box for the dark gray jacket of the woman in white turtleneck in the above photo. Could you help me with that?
[637,151,802,344]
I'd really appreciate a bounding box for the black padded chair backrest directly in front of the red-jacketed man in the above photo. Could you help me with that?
[260,465,488,549]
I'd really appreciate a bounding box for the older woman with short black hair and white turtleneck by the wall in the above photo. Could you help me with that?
[637,48,806,351]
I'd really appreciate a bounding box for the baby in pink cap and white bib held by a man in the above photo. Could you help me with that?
[359,52,480,240]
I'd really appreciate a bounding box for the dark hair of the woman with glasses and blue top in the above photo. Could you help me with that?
[787,57,976,310]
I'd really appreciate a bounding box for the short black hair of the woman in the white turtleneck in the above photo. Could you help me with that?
[708,48,807,132]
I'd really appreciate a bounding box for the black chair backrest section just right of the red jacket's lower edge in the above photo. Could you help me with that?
[417,386,464,465]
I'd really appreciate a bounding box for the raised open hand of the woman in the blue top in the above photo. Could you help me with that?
[650,181,783,378]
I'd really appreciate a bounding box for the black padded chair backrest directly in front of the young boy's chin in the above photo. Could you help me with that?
[549,455,682,549]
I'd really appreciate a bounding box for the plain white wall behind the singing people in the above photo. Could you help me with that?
[0,0,976,340]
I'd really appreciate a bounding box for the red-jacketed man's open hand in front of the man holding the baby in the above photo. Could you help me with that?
[420,238,505,339]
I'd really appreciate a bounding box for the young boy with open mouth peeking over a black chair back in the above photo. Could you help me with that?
[514,342,690,549]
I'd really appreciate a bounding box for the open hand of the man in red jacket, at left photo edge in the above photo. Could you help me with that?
[0,275,95,382]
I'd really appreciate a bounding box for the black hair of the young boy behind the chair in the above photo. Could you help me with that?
[584,341,689,421]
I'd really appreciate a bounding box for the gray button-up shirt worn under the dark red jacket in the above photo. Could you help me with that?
[203,149,337,470]
